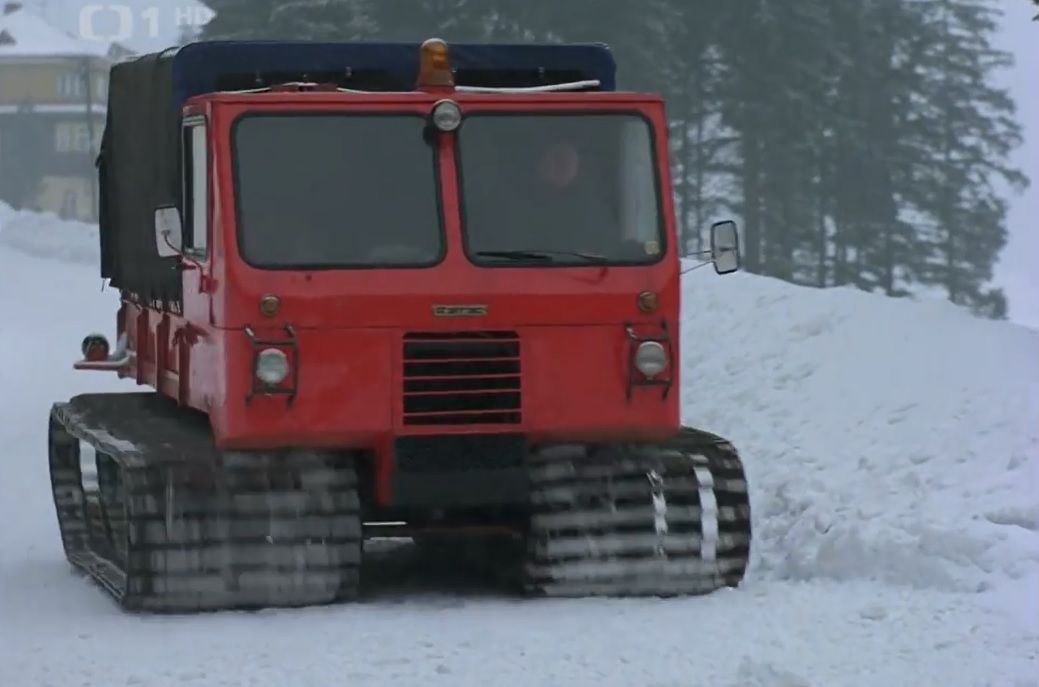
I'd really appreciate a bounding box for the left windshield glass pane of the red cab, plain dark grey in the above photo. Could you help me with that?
[234,113,444,268]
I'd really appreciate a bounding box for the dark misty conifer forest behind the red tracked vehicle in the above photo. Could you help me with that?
[201,0,1029,318]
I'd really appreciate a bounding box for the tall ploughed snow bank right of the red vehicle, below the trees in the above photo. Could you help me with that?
[683,262,1039,594]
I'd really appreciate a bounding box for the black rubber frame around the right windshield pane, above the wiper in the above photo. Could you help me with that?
[451,109,671,269]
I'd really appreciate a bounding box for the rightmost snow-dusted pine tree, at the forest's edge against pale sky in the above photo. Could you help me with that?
[913,0,1029,317]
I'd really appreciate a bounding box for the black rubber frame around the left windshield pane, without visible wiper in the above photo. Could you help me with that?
[228,106,449,272]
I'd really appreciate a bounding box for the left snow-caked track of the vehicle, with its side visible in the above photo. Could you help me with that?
[50,394,362,612]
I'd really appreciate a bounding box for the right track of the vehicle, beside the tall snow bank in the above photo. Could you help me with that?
[526,429,751,597]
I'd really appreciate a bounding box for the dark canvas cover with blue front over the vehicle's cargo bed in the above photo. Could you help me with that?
[98,42,615,301]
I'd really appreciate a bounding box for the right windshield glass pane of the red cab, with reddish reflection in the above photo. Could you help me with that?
[458,113,664,264]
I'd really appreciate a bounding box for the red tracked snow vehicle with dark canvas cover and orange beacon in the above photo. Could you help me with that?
[50,41,751,611]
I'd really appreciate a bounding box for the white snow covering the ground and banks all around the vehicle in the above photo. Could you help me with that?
[0,211,1039,687]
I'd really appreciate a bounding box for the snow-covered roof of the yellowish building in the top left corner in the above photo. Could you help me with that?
[0,3,115,58]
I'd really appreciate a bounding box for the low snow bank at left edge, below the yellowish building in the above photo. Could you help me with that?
[0,202,101,266]
